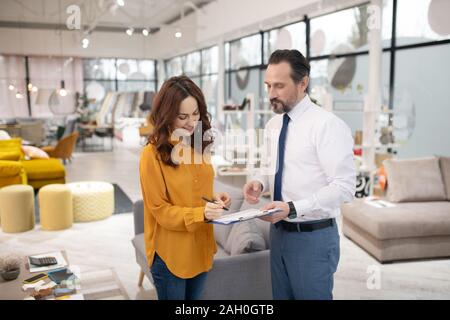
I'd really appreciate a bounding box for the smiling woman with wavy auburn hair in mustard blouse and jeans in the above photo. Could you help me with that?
[140,76,230,300]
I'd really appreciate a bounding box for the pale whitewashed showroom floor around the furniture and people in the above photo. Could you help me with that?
[0,143,450,299]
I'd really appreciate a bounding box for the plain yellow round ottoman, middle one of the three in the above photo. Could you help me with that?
[39,184,73,231]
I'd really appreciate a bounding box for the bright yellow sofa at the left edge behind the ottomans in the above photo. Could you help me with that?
[0,139,66,189]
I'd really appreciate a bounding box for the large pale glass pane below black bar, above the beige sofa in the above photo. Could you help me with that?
[393,44,450,158]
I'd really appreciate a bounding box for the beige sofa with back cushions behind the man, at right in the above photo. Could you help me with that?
[342,157,450,263]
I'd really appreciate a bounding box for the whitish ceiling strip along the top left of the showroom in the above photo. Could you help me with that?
[0,0,214,28]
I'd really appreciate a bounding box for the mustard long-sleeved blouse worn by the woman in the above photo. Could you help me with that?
[140,144,217,279]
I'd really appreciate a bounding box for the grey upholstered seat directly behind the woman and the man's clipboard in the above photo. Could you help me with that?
[132,182,272,300]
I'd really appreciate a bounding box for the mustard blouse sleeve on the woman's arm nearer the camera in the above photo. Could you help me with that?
[140,148,205,232]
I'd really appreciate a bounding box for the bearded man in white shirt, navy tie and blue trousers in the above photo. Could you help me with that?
[243,50,356,299]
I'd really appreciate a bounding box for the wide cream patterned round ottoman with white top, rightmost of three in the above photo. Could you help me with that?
[67,181,114,222]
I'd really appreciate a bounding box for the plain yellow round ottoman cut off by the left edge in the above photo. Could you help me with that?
[0,184,34,233]
